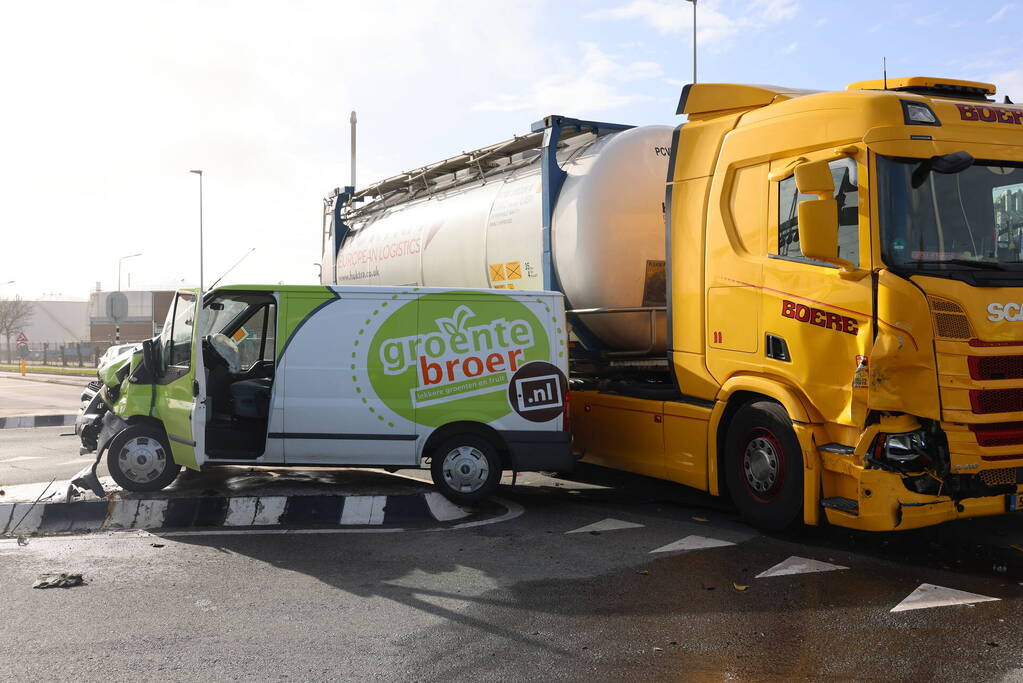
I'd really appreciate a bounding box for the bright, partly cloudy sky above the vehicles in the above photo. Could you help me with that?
[0,0,1023,299]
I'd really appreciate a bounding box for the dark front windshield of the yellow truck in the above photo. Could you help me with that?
[878,156,1023,270]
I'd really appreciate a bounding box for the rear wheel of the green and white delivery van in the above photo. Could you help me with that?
[430,434,503,503]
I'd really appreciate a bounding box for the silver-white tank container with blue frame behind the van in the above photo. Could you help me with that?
[321,117,673,357]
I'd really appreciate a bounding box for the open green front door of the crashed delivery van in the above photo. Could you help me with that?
[153,291,206,468]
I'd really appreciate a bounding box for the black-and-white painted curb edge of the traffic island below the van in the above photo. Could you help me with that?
[0,491,476,536]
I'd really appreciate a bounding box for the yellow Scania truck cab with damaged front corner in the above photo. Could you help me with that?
[572,78,1023,531]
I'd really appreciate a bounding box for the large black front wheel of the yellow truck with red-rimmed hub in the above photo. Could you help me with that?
[724,401,803,531]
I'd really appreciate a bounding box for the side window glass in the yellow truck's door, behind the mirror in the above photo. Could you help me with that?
[777,158,859,265]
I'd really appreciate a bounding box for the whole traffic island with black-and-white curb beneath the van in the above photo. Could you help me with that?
[0,466,509,537]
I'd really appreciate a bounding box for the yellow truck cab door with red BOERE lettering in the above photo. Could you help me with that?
[761,150,873,424]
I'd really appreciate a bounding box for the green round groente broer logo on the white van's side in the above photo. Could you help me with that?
[366,291,550,426]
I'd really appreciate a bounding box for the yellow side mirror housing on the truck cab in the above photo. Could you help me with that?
[795,160,856,270]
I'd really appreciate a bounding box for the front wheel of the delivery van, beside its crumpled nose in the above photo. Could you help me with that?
[106,425,181,492]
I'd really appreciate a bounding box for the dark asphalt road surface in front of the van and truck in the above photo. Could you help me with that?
[0,427,1023,681]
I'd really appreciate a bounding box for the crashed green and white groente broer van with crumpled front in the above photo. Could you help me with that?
[76,286,573,502]
